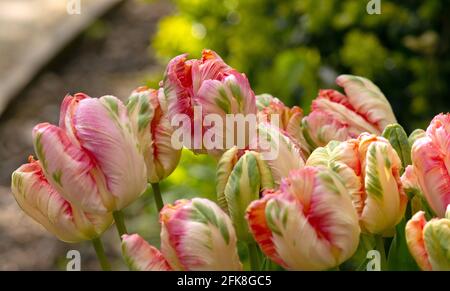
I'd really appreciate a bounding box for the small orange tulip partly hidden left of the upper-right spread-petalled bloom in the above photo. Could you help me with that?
[256,94,310,156]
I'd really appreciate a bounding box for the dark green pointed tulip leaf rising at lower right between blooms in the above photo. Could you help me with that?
[388,218,420,271]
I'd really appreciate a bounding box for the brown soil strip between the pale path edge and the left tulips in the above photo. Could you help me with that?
[0,0,171,270]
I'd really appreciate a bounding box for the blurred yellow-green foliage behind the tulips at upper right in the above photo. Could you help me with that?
[152,0,450,132]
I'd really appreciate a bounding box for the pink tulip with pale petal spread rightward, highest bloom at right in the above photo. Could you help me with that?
[303,75,396,149]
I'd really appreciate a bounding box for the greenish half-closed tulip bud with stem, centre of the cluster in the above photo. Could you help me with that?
[217,147,274,242]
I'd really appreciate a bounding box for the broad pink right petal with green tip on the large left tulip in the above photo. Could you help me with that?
[74,96,147,210]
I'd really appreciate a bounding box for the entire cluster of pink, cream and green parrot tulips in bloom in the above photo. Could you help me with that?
[12,50,450,270]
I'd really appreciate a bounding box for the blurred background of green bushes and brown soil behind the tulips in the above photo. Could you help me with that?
[0,0,450,270]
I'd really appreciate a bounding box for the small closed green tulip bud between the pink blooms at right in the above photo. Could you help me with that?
[382,124,411,173]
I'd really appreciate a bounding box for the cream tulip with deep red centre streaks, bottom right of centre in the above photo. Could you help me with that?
[246,167,360,270]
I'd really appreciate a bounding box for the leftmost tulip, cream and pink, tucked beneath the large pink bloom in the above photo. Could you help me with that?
[11,158,112,243]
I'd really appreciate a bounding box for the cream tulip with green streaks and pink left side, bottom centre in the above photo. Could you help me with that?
[160,198,242,271]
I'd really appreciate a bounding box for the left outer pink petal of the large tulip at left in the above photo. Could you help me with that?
[33,123,107,213]
